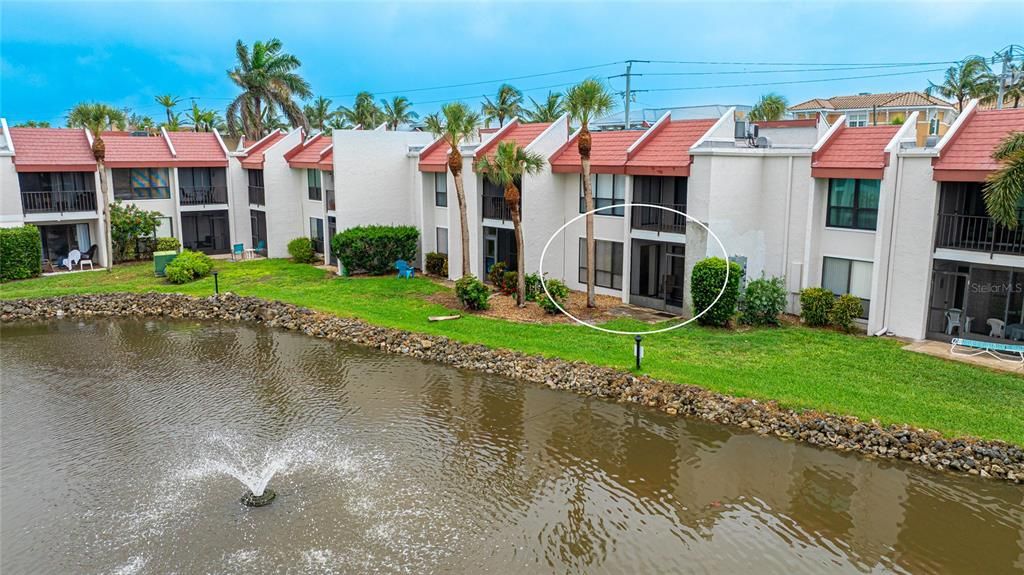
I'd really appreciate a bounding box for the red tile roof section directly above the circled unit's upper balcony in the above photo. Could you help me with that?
[626,119,718,176]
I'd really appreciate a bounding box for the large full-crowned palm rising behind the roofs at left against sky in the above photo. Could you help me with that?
[227,38,312,140]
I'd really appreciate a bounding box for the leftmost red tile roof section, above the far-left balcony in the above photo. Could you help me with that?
[10,128,96,172]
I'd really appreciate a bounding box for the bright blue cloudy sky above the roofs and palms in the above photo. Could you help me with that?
[0,0,1024,124]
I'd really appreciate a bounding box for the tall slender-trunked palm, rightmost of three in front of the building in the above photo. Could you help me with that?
[565,78,615,308]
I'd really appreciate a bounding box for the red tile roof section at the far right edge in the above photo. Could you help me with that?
[932,108,1024,182]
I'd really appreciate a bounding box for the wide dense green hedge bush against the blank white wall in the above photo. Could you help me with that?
[331,225,420,275]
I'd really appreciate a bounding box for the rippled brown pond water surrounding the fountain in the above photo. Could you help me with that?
[0,320,1024,574]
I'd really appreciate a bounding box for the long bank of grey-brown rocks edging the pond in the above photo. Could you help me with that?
[0,293,1024,484]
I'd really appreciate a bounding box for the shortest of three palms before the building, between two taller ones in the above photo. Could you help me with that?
[476,141,544,307]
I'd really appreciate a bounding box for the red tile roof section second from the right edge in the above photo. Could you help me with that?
[811,126,900,180]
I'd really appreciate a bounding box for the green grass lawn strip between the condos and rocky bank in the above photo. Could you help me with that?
[6,260,1024,445]
